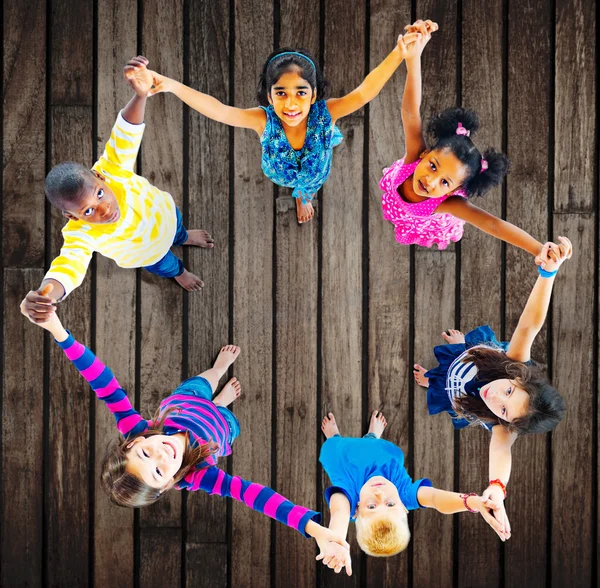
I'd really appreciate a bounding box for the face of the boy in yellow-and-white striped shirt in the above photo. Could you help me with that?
[63,174,121,224]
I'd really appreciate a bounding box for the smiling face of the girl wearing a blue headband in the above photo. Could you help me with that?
[269,66,317,127]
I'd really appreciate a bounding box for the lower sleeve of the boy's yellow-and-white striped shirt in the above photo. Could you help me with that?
[44,223,95,300]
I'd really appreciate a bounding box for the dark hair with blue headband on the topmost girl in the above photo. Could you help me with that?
[257,47,329,106]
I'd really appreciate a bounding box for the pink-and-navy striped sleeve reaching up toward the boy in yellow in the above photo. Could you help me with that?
[57,333,148,437]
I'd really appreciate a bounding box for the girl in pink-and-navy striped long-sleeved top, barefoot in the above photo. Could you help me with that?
[32,308,348,557]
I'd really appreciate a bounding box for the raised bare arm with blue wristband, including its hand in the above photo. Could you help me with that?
[506,237,573,361]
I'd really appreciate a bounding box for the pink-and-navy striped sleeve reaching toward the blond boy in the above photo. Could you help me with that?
[178,467,321,537]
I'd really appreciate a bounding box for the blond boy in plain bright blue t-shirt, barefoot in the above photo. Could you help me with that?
[319,411,502,575]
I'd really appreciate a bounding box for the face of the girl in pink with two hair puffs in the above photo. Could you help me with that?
[413,149,468,198]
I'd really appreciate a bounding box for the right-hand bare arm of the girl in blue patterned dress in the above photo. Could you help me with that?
[327,21,437,123]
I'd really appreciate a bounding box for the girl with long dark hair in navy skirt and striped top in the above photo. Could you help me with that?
[414,237,572,530]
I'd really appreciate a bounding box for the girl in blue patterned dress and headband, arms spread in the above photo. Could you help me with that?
[145,21,437,223]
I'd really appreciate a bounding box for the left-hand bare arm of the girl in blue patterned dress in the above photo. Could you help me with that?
[148,71,267,135]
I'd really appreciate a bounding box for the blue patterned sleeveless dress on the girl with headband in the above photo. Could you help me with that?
[260,100,343,204]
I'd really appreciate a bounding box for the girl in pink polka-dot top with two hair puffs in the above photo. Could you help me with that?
[379,21,542,256]
